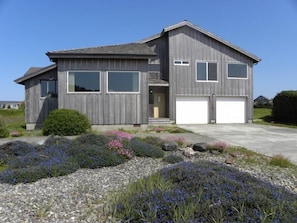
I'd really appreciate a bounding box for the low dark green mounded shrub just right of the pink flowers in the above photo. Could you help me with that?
[130,138,164,158]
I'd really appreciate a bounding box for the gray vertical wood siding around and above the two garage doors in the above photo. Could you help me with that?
[168,26,253,120]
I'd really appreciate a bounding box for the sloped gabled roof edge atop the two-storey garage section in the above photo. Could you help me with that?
[139,20,261,63]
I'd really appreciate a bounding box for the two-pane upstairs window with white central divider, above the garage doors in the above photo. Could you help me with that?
[197,62,218,81]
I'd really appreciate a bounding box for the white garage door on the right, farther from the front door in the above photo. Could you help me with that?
[216,97,246,123]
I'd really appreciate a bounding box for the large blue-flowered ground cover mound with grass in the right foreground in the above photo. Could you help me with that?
[111,161,297,222]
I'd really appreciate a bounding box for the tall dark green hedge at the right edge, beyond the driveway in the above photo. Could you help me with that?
[272,91,297,124]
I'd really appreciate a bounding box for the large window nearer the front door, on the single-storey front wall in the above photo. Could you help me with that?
[107,71,139,92]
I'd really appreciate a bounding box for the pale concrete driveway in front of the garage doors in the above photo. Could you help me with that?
[179,124,297,164]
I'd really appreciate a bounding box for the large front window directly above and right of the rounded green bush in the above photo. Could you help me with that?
[68,71,100,92]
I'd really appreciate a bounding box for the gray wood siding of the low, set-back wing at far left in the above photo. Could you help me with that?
[25,69,58,126]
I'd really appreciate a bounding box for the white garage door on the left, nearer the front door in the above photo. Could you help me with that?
[176,97,209,124]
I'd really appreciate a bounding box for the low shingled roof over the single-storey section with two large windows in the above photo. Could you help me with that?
[46,43,156,61]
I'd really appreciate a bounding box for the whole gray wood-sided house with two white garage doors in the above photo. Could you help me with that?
[15,21,260,129]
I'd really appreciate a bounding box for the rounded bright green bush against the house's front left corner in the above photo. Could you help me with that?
[42,109,91,136]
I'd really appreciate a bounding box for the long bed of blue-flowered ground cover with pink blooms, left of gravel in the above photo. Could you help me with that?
[0,131,164,184]
